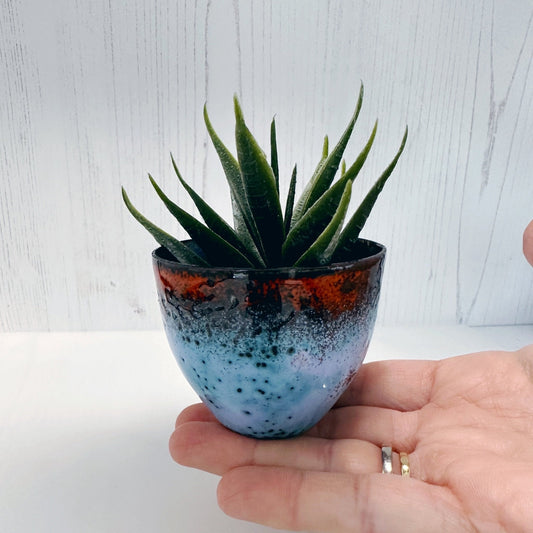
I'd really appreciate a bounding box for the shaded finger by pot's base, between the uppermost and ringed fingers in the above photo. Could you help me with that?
[307,405,419,452]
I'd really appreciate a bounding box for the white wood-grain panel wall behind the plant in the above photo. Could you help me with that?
[0,0,533,331]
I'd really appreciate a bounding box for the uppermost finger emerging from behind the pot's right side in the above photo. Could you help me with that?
[337,361,439,411]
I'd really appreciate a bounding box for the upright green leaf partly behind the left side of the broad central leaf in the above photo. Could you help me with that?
[204,106,264,255]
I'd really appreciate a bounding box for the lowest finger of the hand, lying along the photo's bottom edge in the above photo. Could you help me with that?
[217,467,472,533]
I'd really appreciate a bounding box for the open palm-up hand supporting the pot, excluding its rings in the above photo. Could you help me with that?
[170,345,533,533]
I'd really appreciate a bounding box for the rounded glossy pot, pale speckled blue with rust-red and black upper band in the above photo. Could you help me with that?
[152,240,385,438]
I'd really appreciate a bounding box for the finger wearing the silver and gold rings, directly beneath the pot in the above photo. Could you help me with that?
[169,422,402,476]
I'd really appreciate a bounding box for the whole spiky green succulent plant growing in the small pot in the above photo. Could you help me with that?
[122,84,407,269]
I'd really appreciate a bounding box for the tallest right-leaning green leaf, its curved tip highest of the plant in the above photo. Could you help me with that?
[293,83,364,224]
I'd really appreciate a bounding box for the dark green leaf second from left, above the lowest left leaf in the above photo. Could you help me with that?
[149,176,253,267]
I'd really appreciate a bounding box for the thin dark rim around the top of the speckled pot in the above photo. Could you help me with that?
[152,239,387,277]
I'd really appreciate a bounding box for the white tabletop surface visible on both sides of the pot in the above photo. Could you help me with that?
[0,326,533,533]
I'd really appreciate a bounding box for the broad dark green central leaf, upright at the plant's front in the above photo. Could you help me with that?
[234,97,284,266]
